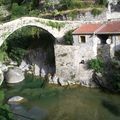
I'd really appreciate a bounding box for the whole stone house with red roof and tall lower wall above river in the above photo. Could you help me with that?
[55,21,120,87]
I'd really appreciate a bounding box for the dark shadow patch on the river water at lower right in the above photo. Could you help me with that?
[102,99,120,116]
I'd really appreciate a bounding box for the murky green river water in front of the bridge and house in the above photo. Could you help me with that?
[6,78,120,120]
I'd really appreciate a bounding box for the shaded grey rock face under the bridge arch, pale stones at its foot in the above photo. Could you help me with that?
[19,48,55,77]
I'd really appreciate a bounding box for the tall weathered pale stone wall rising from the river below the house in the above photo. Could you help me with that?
[55,45,95,87]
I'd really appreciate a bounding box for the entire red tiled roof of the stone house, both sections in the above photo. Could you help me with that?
[73,21,120,35]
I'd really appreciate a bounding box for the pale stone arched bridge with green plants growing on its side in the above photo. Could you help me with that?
[0,17,81,46]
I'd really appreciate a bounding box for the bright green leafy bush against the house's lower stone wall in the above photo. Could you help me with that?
[88,59,104,72]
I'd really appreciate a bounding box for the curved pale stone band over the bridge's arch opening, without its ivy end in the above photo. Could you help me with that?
[0,17,63,46]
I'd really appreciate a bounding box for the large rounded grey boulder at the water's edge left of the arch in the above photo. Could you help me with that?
[5,67,25,83]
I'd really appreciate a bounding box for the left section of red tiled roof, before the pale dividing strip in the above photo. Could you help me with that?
[73,23,102,34]
